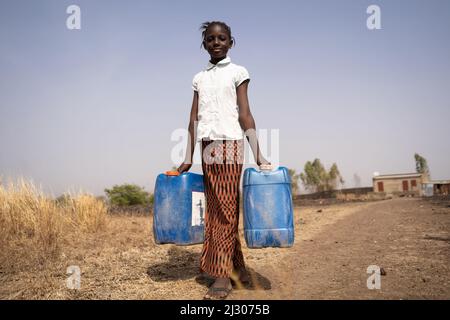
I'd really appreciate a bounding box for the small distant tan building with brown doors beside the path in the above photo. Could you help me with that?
[373,173,428,196]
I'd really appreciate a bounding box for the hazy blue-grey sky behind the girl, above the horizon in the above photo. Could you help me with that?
[0,0,450,195]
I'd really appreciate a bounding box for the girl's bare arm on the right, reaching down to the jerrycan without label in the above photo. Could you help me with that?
[236,80,270,166]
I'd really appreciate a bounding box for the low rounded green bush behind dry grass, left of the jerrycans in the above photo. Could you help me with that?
[105,184,153,206]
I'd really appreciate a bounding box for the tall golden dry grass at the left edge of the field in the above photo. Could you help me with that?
[0,179,107,271]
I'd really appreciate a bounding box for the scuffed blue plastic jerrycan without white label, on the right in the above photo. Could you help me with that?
[243,167,294,248]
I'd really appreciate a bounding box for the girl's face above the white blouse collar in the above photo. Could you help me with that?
[203,24,233,61]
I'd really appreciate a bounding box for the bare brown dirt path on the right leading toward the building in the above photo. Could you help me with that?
[234,199,450,299]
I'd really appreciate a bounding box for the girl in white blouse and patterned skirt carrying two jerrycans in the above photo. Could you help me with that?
[178,21,269,299]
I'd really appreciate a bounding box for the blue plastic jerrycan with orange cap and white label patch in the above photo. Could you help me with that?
[153,171,206,245]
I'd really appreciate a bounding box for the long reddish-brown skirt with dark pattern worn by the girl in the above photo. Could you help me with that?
[200,139,245,277]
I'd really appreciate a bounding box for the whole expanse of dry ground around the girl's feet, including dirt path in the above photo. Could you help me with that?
[0,198,450,299]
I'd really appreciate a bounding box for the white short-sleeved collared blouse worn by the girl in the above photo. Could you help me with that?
[192,57,250,141]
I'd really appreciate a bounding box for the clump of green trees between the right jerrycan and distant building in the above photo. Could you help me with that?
[300,158,344,192]
